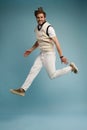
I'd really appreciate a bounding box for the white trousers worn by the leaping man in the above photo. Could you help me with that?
[21,52,71,91]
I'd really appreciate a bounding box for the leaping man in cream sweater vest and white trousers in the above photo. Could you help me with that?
[10,7,78,96]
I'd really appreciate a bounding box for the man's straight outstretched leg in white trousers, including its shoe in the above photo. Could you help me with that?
[10,55,42,96]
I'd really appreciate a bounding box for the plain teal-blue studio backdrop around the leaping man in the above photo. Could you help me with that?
[0,0,87,130]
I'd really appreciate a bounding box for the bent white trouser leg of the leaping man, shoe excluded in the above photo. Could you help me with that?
[44,53,72,79]
